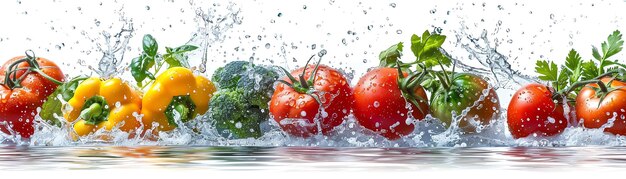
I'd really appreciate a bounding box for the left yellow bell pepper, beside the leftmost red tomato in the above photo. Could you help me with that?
[63,77,141,136]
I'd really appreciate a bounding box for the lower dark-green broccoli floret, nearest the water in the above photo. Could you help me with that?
[209,89,268,138]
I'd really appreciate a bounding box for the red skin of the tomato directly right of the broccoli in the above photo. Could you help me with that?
[269,65,354,138]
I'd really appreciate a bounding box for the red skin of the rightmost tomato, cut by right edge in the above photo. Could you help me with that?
[576,77,626,135]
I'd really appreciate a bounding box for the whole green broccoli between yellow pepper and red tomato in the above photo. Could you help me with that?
[209,61,278,138]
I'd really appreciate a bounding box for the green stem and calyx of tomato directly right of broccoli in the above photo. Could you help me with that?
[276,55,322,105]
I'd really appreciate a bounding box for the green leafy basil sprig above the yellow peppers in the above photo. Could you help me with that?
[130,34,198,87]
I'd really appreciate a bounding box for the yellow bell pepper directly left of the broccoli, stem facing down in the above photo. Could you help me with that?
[141,67,216,132]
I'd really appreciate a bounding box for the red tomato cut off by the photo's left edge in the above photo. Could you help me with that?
[0,56,64,138]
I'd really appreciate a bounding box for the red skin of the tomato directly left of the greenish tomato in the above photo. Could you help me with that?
[353,67,430,140]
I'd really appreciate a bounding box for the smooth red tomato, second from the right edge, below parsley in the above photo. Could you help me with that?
[507,83,574,139]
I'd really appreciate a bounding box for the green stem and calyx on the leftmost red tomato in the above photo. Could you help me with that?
[0,50,63,89]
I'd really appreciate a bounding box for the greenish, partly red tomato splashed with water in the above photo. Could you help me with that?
[430,73,500,133]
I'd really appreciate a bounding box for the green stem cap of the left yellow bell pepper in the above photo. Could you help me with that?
[79,95,110,125]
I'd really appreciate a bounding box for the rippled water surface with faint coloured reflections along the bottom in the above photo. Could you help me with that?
[0,146,626,171]
